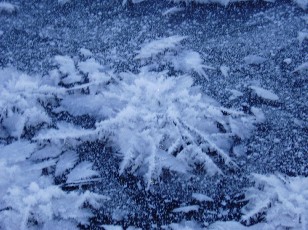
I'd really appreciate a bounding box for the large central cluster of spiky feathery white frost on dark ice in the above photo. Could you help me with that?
[35,36,257,188]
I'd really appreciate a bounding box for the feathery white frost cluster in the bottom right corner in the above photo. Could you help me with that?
[242,174,308,229]
